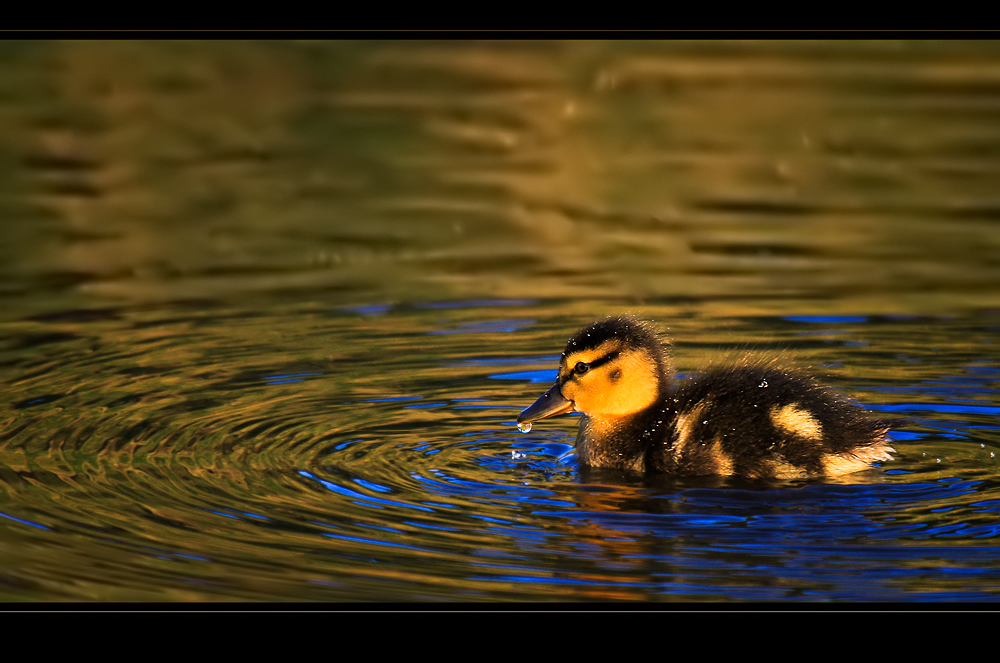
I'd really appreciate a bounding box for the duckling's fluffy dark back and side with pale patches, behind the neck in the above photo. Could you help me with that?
[646,363,893,478]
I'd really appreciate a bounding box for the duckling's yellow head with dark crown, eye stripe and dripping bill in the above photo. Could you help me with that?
[517,315,673,425]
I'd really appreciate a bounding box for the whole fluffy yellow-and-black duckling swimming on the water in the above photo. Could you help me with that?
[517,315,895,479]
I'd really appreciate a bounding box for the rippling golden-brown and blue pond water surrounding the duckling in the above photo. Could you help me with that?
[0,42,1000,601]
